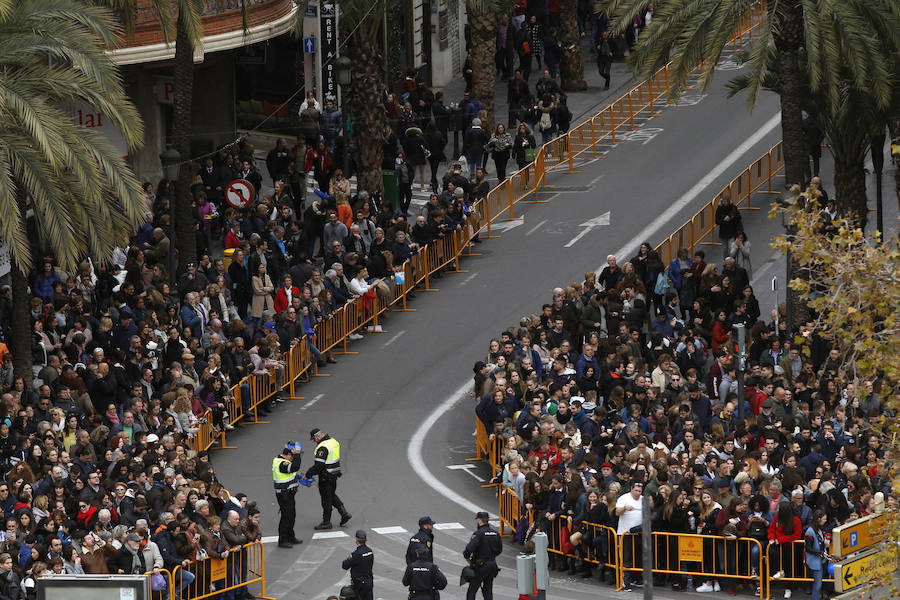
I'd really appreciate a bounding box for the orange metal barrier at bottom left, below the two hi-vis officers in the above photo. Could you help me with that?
[168,542,274,600]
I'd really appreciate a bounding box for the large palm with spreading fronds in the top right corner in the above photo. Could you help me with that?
[602,0,900,189]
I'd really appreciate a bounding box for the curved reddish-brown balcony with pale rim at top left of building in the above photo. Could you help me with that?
[111,0,298,65]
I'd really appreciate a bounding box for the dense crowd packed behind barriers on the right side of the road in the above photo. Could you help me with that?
[473,234,897,600]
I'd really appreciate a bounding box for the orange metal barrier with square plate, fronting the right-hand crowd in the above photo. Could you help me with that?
[620,531,766,597]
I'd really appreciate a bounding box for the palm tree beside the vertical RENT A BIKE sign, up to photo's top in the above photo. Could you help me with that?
[341,0,386,194]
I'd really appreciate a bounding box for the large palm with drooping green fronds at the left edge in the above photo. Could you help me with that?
[0,0,145,381]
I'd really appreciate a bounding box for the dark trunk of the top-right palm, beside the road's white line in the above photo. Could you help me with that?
[769,0,809,187]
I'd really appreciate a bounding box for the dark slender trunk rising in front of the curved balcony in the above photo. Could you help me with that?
[172,15,197,273]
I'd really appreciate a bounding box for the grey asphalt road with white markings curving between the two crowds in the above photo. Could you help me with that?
[213,57,780,600]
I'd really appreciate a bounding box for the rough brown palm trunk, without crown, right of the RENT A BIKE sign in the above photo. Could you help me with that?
[349,40,384,194]
